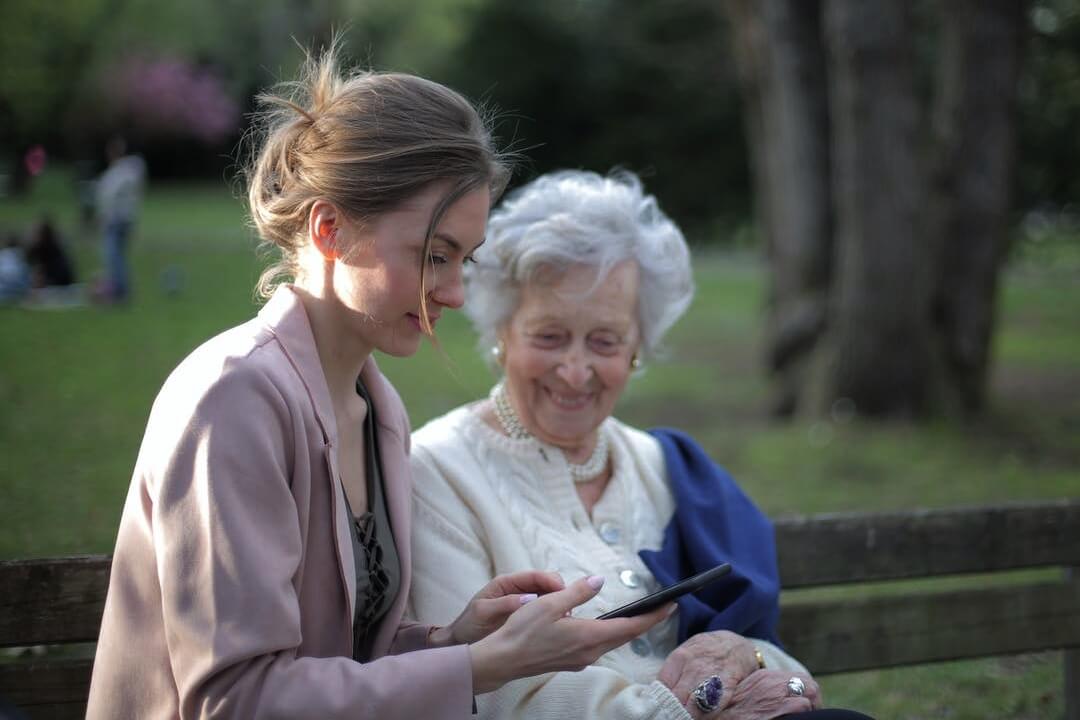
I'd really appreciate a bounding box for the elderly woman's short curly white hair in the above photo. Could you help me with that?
[464,171,693,367]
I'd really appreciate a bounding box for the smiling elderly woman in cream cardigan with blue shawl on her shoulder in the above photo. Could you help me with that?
[410,172,862,720]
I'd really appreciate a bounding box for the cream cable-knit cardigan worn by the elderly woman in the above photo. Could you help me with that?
[409,405,806,720]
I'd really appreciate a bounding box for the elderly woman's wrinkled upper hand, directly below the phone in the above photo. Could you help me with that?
[657,630,760,709]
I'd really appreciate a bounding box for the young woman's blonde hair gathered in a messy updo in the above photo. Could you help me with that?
[246,40,510,335]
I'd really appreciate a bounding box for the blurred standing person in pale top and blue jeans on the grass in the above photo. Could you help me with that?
[95,135,146,302]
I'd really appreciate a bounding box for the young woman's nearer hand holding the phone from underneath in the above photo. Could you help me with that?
[470,575,674,694]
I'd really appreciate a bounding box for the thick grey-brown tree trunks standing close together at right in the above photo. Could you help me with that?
[726,0,1027,416]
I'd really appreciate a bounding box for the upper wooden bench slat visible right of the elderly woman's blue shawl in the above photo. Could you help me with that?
[775,500,1080,589]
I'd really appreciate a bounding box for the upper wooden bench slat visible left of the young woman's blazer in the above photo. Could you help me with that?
[0,555,110,647]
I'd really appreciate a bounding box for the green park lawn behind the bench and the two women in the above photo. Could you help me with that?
[0,173,1080,719]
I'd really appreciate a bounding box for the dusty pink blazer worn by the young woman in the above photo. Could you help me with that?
[87,287,472,720]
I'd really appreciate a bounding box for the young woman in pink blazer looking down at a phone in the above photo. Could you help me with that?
[89,47,673,720]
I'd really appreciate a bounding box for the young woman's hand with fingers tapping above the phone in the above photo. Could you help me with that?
[438,570,565,647]
